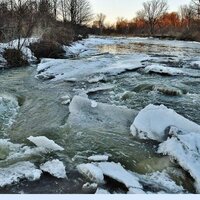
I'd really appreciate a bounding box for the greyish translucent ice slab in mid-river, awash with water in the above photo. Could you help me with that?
[67,96,136,132]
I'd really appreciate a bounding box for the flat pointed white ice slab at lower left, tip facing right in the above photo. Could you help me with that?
[27,136,64,151]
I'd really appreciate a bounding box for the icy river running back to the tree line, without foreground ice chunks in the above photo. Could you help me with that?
[0,37,200,194]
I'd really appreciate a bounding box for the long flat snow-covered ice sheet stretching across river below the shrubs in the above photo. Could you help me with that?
[36,54,149,83]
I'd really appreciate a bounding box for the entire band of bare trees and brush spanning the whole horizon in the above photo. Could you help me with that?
[0,0,200,43]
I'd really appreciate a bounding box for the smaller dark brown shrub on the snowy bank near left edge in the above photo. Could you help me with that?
[3,49,29,67]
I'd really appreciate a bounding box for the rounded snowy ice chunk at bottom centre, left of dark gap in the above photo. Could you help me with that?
[77,163,104,184]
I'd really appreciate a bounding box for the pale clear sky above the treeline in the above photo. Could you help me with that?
[89,0,191,23]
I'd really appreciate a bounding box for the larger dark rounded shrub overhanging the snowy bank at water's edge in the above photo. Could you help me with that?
[29,40,65,59]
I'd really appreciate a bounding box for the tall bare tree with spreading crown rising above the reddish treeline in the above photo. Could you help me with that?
[138,0,168,35]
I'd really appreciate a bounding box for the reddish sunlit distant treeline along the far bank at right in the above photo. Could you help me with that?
[92,0,200,41]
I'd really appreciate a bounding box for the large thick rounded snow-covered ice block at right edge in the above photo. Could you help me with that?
[130,104,200,142]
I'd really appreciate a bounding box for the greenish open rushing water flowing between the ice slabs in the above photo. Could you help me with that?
[0,36,200,193]
